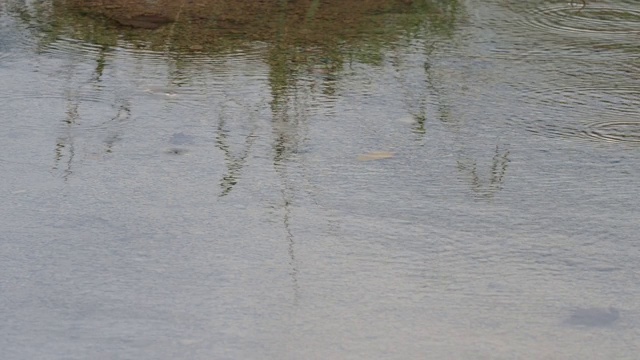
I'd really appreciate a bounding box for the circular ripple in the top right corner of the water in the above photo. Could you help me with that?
[525,1,640,37]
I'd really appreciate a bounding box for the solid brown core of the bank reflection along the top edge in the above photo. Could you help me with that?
[53,0,455,42]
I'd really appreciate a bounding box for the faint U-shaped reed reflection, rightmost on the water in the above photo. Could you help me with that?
[458,145,510,199]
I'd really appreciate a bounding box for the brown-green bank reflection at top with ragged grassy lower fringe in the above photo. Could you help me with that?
[11,0,459,111]
